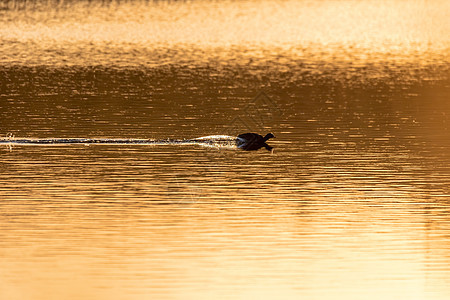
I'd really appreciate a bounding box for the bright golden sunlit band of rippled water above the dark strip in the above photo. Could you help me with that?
[0,0,450,66]
